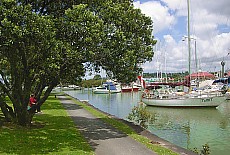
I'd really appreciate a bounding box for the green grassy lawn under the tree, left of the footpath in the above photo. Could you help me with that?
[0,96,94,155]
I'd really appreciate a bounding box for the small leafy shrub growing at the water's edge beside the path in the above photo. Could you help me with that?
[127,105,154,128]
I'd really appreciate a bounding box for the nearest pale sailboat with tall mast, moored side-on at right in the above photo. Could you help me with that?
[142,0,224,107]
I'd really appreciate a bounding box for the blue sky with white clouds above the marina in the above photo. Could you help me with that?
[134,0,230,73]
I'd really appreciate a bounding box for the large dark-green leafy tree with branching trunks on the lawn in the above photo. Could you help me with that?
[0,0,155,126]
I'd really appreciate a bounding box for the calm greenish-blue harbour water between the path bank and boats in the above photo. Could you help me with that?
[65,90,230,155]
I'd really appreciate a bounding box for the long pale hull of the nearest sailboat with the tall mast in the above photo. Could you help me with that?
[142,97,224,107]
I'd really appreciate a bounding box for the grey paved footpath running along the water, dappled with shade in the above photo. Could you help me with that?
[57,95,196,155]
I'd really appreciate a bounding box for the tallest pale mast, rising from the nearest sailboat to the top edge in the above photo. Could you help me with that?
[187,0,191,75]
